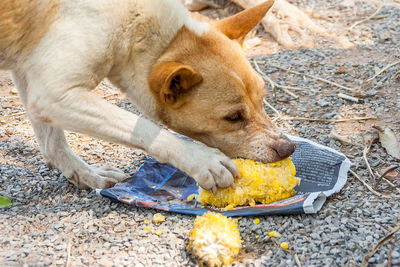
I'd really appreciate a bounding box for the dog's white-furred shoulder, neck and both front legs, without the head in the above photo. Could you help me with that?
[3,0,236,189]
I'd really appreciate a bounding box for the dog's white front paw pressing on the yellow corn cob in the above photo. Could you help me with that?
[186,145,239,193]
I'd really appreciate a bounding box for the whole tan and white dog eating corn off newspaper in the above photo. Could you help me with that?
[0,0,294,193]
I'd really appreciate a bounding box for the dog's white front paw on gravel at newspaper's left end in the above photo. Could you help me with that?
[65,165,127,189]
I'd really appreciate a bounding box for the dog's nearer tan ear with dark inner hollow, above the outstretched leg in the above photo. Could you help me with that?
[149,62,203,105]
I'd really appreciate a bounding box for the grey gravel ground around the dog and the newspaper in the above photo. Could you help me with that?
[0,0,400,266]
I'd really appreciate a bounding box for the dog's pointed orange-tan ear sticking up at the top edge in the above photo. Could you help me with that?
[213,0,275,44]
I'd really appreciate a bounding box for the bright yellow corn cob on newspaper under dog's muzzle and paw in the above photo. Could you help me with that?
[197,158,300,210]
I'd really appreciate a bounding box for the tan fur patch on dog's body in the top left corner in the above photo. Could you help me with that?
[0,0,59,65]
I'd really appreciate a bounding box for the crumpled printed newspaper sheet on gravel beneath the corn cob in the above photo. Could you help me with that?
[96,136,351,216]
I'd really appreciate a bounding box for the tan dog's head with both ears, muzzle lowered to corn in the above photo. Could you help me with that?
[149,1,295,162]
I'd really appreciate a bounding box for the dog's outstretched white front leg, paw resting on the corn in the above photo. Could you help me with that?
[28,87,238,191]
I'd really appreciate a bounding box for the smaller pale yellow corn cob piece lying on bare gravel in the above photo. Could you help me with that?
[188,212,241,266]
